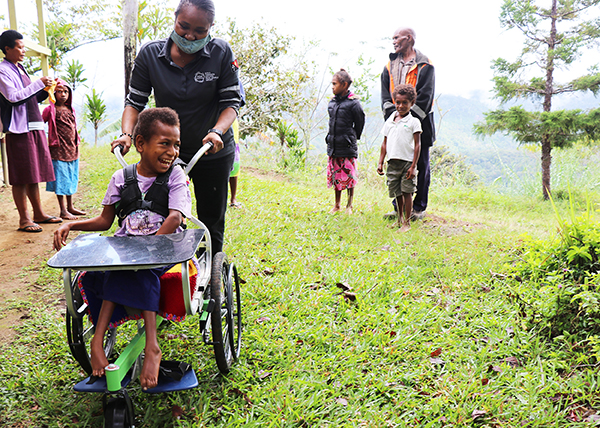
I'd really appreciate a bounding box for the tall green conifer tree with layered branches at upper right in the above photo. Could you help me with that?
[474,0,600,198]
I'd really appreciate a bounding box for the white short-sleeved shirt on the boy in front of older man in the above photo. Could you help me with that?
[381,111,423,162]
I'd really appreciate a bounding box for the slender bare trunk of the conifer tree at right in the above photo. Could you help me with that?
[542,0,558,200]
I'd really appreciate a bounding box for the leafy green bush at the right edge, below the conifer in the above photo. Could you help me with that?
[510,204,600,339]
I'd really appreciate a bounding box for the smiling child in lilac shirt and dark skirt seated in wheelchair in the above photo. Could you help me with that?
[54,108,192,390]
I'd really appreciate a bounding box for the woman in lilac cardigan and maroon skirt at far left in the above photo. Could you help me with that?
[0,30,62,233]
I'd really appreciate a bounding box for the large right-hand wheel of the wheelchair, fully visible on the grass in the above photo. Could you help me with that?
[210,253,234,374]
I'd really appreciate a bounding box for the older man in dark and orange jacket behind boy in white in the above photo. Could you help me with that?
[381,28,435,219]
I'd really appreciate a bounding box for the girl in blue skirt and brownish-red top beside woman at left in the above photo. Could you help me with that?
[42,79,85,220]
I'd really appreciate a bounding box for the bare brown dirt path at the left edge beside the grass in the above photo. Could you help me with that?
[0,184,68,345]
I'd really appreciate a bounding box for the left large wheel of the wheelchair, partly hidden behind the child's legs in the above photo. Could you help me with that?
[65,272,117,375]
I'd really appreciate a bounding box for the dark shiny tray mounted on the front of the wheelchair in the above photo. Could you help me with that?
[48,229,205,271]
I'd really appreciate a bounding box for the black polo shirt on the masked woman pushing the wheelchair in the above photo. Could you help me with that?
[125,39,241,162]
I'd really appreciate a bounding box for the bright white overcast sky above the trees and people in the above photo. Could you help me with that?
[0,0,596,103]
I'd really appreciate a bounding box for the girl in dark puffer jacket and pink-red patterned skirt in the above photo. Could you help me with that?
[326,68,365,214]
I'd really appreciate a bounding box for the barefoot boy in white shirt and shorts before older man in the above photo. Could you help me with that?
[377,85,422,232]
